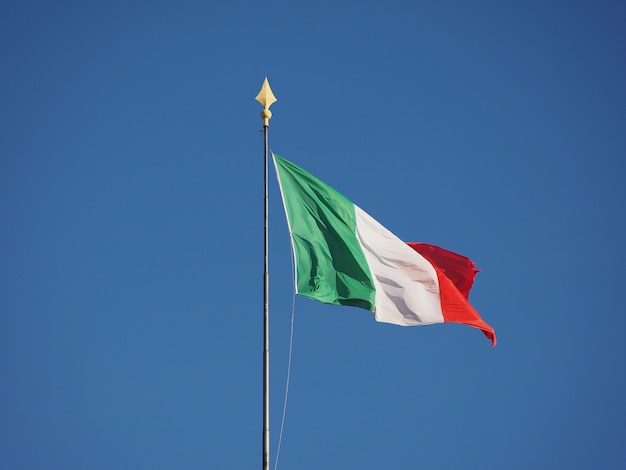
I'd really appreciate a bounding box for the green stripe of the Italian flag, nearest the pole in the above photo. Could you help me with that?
[274,155,375,311]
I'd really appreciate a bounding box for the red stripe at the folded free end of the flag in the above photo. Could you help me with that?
[407,242,496,346]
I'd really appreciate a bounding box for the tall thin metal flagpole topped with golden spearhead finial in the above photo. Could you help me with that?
[256,77,276,470]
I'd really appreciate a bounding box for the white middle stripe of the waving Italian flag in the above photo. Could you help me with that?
[354,205,443,326]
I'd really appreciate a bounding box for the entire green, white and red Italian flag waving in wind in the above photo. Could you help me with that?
[273,154,496,346]
